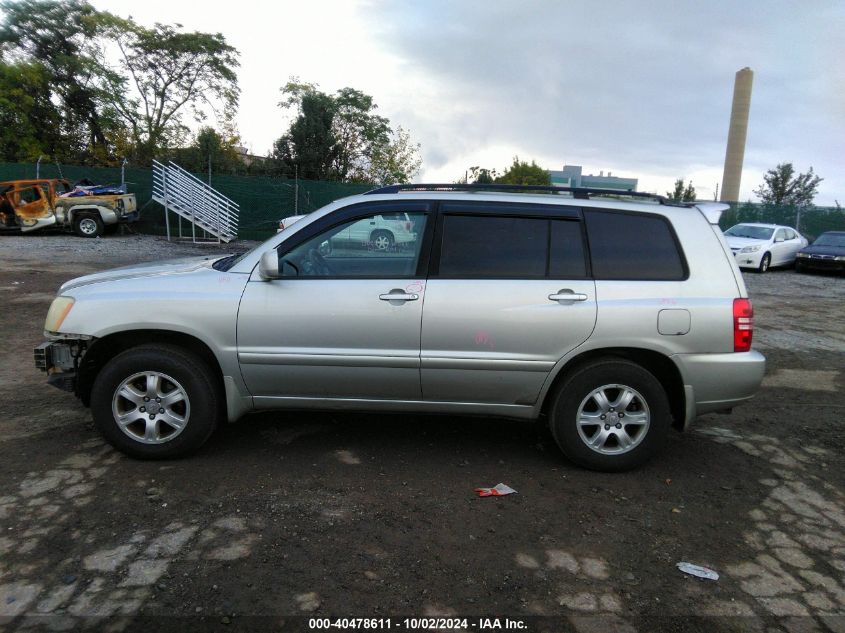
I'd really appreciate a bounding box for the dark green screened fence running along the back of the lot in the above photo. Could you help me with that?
[0,163,845,240]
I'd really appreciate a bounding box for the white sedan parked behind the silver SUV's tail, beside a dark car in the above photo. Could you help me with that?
[725,222,807,273]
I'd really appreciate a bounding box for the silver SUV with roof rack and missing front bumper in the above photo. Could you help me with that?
[35,185,765,471]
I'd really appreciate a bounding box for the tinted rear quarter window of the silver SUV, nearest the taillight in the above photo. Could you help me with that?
[584,210,687,281]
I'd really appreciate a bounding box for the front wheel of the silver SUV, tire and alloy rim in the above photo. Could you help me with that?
[91,345,221,459]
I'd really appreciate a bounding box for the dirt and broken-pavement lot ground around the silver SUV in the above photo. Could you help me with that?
[0,235,845,632]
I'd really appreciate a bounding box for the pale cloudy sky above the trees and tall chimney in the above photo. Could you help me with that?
[93,0,845,205]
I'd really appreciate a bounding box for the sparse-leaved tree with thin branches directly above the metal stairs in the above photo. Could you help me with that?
[108,18,240,163]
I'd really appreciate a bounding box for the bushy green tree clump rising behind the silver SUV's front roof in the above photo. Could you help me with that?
[271,77,421,184]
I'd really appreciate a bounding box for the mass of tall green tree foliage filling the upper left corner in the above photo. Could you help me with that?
[0,0,238,164]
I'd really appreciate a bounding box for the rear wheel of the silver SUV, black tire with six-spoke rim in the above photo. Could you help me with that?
[549,358,672,472]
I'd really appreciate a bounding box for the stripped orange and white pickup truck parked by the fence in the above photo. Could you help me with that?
[0,179,140,237]
